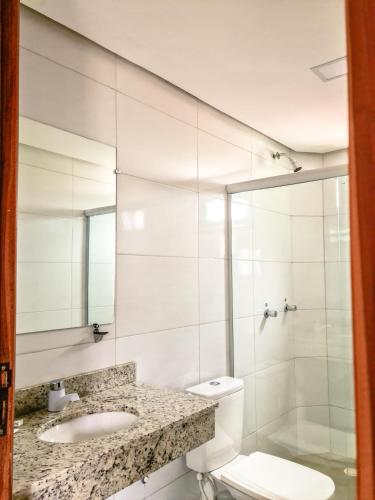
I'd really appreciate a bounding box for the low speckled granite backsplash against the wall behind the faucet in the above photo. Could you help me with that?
[14,362,135,418]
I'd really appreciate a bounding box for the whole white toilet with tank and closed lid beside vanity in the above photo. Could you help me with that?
[186,377,335,500]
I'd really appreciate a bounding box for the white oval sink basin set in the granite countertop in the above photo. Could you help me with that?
[39,411,138,443]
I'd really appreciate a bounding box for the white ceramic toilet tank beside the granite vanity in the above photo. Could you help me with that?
[186,377,244,473]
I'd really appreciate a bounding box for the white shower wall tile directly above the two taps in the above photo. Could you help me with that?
[254,261,294,314]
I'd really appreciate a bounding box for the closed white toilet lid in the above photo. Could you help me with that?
[221,451,335,500]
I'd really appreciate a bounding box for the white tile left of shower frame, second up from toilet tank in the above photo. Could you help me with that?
[199,259,228,323]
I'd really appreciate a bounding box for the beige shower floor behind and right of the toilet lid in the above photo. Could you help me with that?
[293,453,356,500]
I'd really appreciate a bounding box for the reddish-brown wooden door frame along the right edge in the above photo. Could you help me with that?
[346,0,375,500]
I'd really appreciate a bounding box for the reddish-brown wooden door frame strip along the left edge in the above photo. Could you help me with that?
[0,0,19,500]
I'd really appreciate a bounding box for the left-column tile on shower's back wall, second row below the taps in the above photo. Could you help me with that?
[295,357,328,406]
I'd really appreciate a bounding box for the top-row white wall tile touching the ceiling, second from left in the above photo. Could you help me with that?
[117,58,198,126]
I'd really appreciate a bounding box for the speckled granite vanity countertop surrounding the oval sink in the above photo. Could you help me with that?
[13,364,216,500]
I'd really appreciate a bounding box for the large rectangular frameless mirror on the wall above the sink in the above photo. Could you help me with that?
[16,117,116,334]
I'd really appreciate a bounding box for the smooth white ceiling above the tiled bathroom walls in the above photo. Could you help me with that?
[22,0,348,152]
